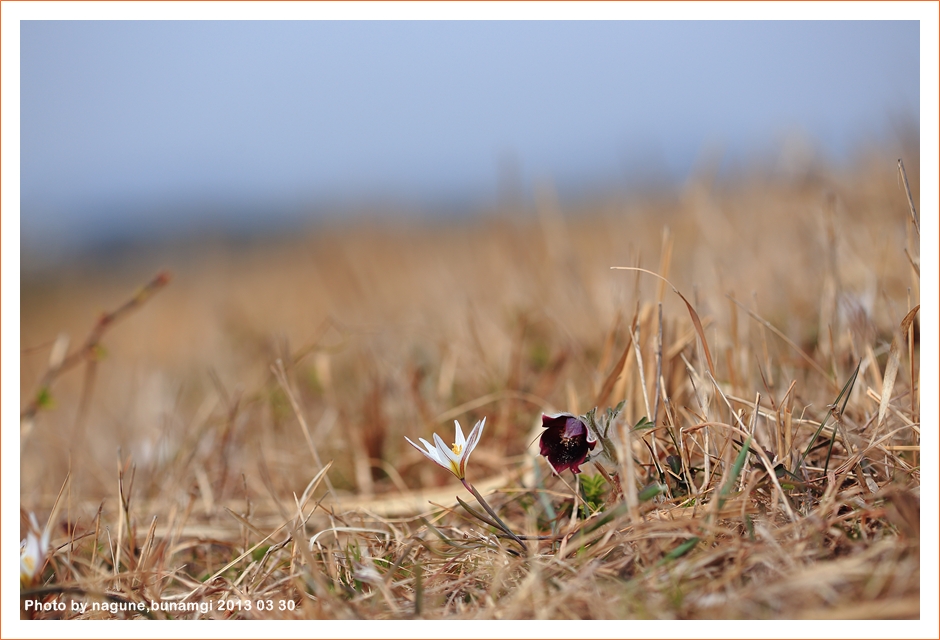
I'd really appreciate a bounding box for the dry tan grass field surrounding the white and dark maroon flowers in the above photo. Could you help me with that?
[20,149,920,619]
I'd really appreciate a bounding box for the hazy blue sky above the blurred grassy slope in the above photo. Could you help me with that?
[14,14,920,251]
